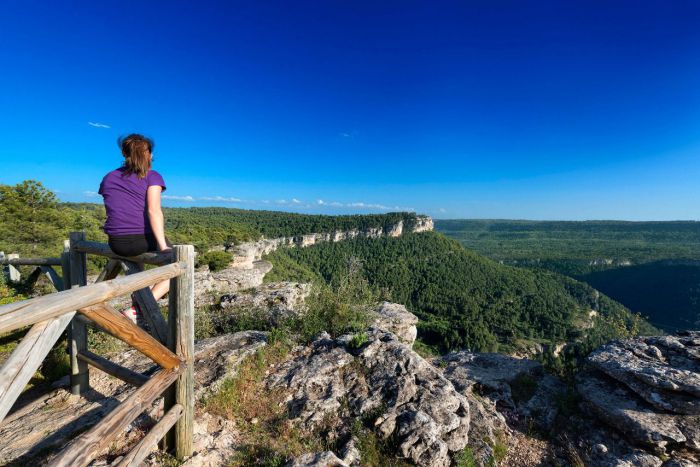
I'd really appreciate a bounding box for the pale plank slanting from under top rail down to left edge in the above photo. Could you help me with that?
[0,311,75,423]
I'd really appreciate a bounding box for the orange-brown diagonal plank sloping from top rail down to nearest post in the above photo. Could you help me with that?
[78,303,183,368]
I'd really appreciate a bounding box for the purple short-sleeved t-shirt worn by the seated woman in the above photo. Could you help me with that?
[98,167,165,236]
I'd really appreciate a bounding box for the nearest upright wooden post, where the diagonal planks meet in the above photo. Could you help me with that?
[165,245,194,460]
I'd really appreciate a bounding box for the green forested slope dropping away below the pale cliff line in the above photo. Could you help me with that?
[267,232,655,351]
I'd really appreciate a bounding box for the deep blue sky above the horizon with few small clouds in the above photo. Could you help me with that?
[0,0,700,220]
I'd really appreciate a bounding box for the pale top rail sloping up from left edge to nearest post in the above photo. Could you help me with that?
[0,263,186,333]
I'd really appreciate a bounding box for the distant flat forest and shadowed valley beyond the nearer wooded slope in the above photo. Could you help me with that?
[435,219,700,331]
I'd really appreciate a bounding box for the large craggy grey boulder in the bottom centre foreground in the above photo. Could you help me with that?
[267,328,469,466]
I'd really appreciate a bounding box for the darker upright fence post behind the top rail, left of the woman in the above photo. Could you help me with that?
[64,232,90,395]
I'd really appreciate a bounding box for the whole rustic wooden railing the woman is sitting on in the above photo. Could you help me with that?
[0,232,194,466]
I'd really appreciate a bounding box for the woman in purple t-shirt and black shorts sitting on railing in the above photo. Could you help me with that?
[99,133,172,323]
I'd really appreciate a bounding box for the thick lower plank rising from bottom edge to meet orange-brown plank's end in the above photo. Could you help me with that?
[49,369,178,467]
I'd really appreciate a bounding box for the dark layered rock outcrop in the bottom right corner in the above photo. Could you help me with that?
[577,331,700,465]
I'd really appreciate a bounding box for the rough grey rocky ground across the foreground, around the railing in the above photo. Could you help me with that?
[0,236,700,467]
